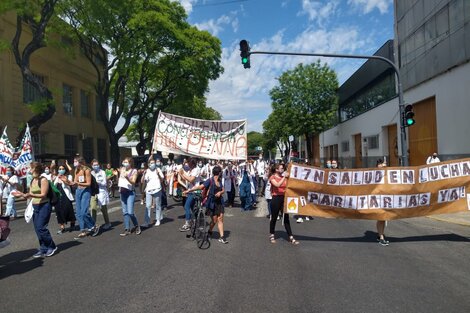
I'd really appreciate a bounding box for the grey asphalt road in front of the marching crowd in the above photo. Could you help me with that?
[0,196,470,313]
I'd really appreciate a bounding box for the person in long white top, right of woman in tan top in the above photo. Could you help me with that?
[90,160,111,230]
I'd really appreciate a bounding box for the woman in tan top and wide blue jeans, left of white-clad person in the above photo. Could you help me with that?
[73,156,100,239]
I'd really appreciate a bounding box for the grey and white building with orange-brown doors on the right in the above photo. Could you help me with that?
[313,0,470,168]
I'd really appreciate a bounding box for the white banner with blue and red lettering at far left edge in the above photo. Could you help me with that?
[0,126,34,178]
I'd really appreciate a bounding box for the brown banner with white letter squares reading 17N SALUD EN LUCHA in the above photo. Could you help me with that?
[284,159,470,220]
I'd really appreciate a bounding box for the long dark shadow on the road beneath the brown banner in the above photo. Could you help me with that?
[294,231,470,242]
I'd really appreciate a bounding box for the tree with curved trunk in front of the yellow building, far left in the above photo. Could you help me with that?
[0,0,58,143]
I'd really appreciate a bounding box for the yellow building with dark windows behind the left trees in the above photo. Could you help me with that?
[0,14,109,162]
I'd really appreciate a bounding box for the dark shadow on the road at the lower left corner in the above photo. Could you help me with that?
[0,241,81,280]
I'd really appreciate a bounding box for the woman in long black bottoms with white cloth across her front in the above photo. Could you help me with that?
[54,165,76,234]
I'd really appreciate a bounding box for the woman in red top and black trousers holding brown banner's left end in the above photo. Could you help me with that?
[269,163,299,245]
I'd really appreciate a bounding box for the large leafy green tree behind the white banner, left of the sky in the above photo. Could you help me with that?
[62,0,222,165]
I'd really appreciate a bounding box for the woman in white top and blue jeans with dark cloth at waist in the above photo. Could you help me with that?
[116,157,142,237]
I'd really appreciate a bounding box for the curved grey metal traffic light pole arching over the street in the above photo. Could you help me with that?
[249,51,409,166]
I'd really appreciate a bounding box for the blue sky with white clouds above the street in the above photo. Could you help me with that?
[176,0,393,132]
